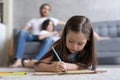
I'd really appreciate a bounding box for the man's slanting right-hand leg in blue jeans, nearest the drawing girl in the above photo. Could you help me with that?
[23,37,53,68]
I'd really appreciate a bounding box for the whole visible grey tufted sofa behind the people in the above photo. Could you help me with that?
[14,20,120,64]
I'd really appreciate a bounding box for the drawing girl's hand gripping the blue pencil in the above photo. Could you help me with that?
[51,61,67,72]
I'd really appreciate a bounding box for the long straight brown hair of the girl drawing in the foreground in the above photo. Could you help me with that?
[40,16,97,70]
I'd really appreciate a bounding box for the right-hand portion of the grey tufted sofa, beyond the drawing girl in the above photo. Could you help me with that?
[93,20,120,64]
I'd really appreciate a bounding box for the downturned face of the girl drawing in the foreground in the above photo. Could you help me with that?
[66,31,87,53]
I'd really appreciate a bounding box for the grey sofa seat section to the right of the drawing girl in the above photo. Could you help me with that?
[95,38,120,57]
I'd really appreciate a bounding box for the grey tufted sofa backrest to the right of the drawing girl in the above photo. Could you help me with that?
[93,20,120,38]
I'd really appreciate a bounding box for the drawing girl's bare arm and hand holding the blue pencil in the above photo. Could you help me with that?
[34,55,66,72]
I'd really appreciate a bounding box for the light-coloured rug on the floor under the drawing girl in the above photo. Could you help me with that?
[0,65,120,80]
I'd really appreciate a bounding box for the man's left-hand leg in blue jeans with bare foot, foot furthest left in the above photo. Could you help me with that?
[10,30,34,67]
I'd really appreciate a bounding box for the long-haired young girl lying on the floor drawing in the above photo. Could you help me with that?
[34,16,97,72]
